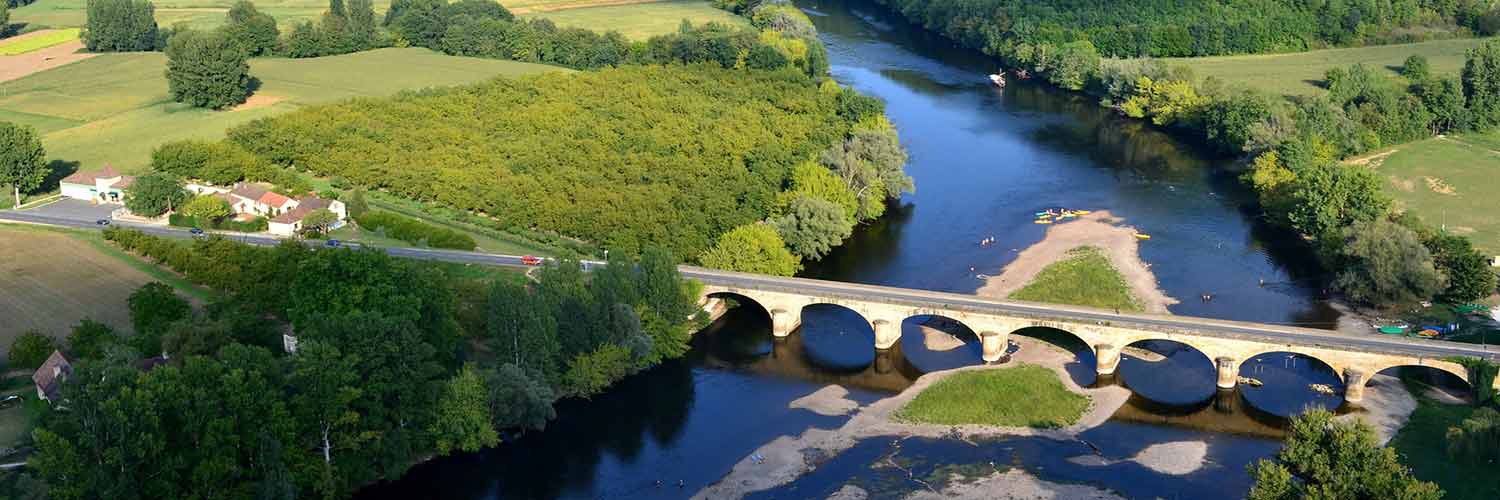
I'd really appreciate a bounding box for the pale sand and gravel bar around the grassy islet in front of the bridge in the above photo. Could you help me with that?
[695,336,1130,498]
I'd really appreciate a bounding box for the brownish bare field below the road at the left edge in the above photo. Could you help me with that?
[0,224,207,342]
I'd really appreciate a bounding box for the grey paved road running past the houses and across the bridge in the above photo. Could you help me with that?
[0,210,1500,360]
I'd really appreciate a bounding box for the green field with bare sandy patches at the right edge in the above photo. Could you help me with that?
[1368,131,1500,255]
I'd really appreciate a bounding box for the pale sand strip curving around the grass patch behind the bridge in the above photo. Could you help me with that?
[975,210,1178,314]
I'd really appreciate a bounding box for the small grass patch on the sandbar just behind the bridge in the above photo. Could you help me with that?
[1011,246,1142,311]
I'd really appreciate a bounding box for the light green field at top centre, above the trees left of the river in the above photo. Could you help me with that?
[519,0,749,39]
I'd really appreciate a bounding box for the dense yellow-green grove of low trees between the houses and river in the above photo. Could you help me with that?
[230,65,881,258]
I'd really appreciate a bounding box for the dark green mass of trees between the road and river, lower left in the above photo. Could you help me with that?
[12,228,698,498]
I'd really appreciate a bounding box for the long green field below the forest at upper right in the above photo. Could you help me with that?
[1167,39,1487,96]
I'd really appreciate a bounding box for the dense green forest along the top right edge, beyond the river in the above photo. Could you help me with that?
[878,0,1500,60]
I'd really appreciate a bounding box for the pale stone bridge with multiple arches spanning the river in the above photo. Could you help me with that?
[683,266,1500,402]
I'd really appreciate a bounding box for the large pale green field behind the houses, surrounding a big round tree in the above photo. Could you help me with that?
[0,48,563,171]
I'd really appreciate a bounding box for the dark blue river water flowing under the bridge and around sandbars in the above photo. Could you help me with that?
[359,0,1362,498]
